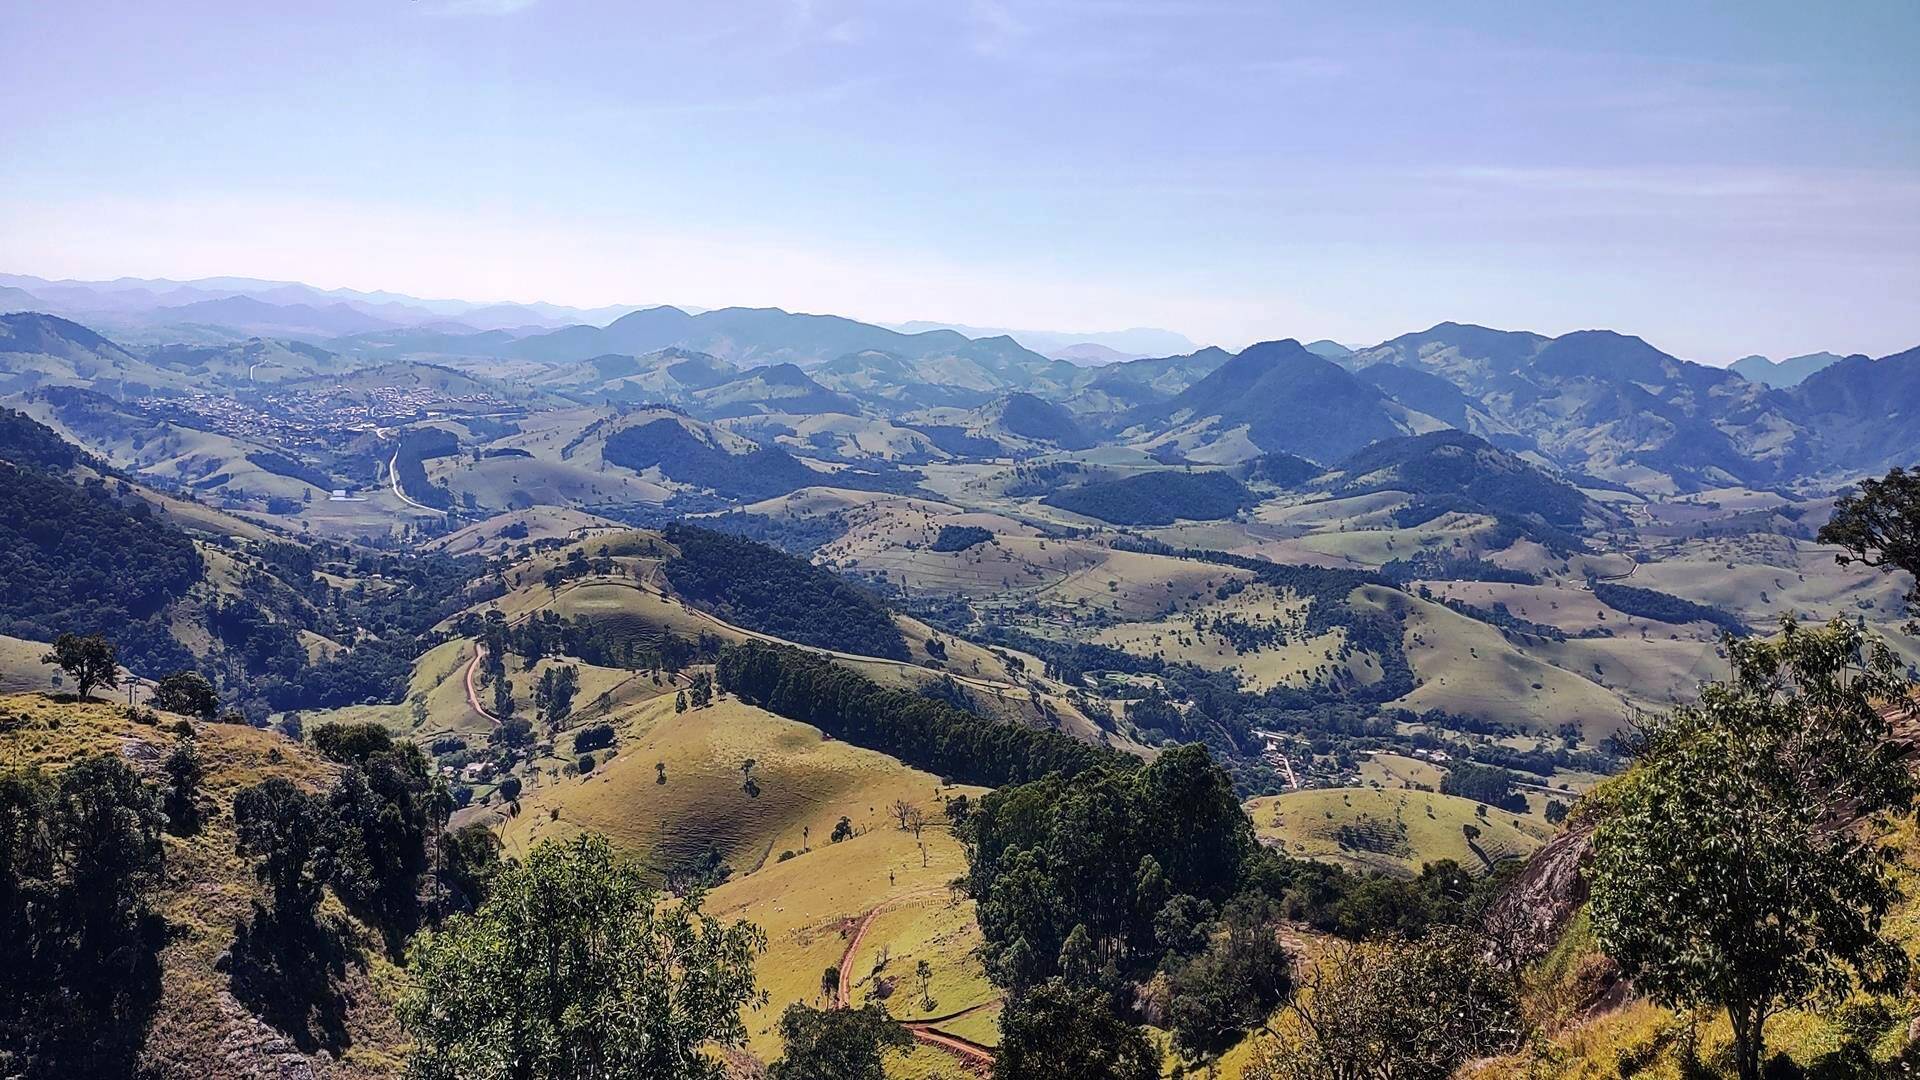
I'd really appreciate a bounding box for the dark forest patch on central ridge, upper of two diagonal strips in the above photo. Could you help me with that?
[664,525,908,659]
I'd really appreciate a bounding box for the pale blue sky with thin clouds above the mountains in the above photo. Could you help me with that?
[0,0,1920,363]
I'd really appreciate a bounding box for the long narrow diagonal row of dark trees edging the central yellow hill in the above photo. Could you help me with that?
[716,642,1131,786]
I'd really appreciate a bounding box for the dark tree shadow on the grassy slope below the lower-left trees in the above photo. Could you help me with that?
[228,905,367,1055]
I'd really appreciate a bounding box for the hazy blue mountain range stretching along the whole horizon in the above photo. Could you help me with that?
[0,295,1920,494]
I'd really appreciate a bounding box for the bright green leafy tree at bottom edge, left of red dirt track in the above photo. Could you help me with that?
[401,834,766,1080]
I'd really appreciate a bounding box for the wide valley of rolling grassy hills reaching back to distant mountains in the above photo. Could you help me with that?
[0,286,1920,1078]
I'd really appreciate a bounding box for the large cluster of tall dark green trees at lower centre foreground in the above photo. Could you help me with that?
[952,730,1511,1076]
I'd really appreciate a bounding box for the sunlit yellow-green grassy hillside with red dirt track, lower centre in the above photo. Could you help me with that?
[501,694,995,1076]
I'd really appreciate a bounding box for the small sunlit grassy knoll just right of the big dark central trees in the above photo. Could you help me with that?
[1246,788,1553,876]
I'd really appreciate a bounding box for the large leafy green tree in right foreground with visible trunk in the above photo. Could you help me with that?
[1592,621,1914,1080]
